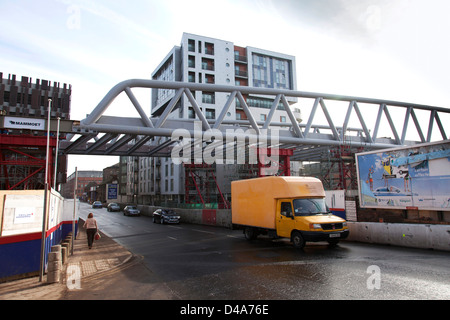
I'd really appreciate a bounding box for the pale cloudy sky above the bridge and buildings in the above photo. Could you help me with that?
[0,0,450,175]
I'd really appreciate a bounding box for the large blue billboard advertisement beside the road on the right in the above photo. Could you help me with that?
[356,140,450,211]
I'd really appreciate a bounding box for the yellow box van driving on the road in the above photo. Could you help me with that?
[231,176,349,248]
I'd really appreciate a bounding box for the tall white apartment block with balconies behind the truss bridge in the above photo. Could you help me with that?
[137,33,300,204]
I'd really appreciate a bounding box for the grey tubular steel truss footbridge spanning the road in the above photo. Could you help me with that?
[59,79,450,161]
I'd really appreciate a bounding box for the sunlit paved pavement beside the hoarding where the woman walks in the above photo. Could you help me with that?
[0,220,178,300]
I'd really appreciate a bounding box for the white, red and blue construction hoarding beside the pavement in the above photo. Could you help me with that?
[0,189,78,282]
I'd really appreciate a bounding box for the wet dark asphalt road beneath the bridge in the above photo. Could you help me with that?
[80,204,450,300]
